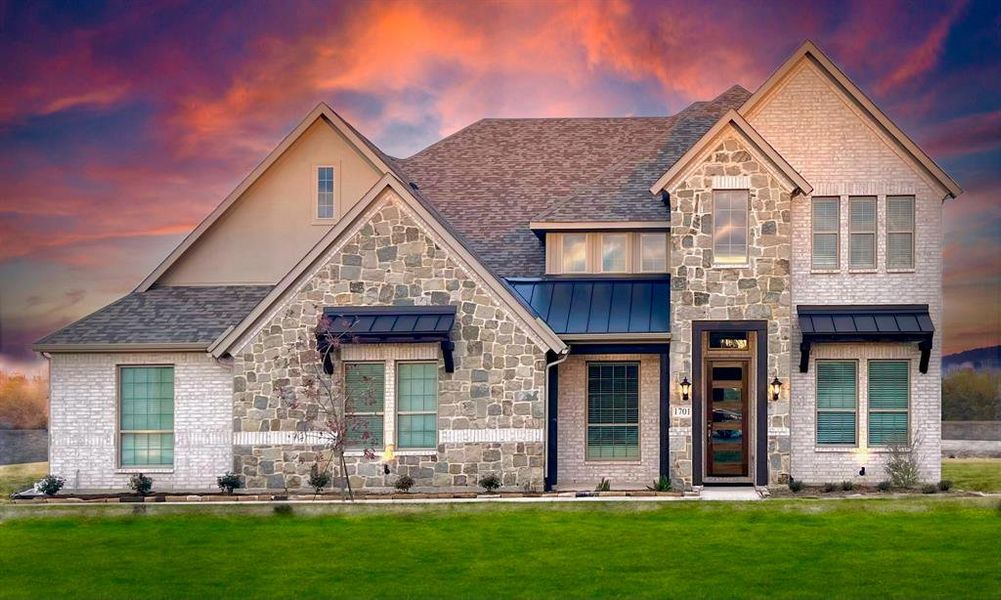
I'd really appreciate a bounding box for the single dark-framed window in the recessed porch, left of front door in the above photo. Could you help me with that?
[586,363,640,460]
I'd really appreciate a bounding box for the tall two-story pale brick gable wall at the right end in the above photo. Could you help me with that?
[745,61,944,485]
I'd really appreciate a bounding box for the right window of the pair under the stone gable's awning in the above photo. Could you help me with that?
[396,363,437,448]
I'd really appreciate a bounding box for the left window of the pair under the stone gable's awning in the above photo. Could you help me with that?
[344,363,385,450]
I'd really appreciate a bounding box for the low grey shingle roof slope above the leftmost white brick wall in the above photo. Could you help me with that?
[35,285,271,350]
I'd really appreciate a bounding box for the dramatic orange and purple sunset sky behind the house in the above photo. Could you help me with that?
[0,0,1001,376]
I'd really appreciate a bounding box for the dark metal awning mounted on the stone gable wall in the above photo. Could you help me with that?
[316,306,455,373]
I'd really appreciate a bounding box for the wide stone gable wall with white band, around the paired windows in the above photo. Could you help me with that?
[233,192,546,490]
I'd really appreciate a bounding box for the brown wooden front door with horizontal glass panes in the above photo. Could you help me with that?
[706,360,750,477]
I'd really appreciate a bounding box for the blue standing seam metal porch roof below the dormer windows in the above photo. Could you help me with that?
[508,275,671,336]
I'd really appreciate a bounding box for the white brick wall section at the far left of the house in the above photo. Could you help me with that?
[49,353,233,491]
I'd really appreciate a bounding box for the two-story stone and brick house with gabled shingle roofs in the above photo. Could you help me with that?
[35,42,961,490]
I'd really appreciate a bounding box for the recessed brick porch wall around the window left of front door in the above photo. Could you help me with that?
[557,355,661,490]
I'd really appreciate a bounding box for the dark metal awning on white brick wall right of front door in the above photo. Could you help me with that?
[797,305,935,373]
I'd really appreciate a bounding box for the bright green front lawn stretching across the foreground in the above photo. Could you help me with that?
[0,498,1001,598]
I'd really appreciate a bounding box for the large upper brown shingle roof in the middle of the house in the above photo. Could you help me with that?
[394,86,750,276]
